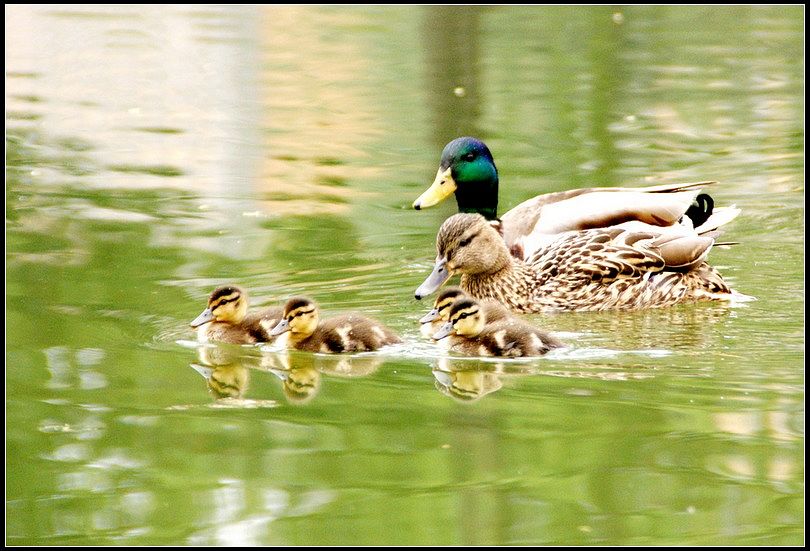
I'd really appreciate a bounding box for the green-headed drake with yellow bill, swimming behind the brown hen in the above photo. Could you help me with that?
[413,137,740,259]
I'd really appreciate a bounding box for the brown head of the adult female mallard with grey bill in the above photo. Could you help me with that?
[414,213,511,300]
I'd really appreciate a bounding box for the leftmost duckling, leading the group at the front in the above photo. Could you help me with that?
[191,285,282,344]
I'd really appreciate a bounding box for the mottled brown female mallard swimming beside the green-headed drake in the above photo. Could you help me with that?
[416,214,743,312]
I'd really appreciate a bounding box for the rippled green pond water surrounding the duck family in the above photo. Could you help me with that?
[5,6,804,545]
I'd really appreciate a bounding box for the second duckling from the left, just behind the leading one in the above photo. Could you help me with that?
[270,297,402,353]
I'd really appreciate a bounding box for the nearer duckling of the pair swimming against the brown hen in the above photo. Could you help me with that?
[433,298,562,358]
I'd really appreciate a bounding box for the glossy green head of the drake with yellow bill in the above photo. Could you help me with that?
[413,137,498,220]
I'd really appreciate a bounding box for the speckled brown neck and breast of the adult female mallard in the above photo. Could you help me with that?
[461,257,536,312]
